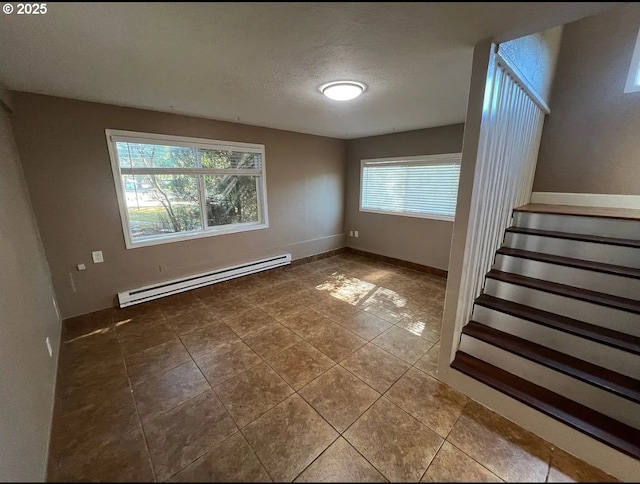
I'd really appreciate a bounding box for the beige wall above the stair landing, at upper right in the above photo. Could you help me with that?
[533,4,640,195]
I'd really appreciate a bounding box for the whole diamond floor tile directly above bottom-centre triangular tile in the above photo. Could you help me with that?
[298,366,380,433]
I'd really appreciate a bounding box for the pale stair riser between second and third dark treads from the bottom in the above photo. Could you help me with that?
[473,305,640,380]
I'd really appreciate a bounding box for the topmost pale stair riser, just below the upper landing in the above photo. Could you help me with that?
[513,212,640,240]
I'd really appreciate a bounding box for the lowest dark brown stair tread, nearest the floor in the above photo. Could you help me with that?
[451,351,640,459]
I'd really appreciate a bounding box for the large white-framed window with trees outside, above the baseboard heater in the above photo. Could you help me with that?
[106,130,268,248]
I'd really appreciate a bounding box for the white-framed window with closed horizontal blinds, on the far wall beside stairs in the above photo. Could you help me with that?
[360,153,460,220]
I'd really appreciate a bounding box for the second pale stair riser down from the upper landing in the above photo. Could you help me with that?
[504,232,640,269]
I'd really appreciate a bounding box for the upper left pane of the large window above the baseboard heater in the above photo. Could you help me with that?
[116,141,196,168]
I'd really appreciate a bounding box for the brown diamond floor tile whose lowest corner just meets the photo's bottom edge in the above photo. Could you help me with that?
[242,394,338,481]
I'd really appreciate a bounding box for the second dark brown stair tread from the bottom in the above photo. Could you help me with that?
[462,321,640,403]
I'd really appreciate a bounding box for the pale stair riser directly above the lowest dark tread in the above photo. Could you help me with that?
[460,334,640,428]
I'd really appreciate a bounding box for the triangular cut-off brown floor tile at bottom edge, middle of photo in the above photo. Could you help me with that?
[295,437,387,482]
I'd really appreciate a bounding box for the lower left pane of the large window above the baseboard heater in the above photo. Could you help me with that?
[122,175,202,240]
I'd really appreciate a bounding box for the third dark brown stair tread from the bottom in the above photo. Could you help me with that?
[475,294,640,355]
